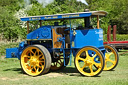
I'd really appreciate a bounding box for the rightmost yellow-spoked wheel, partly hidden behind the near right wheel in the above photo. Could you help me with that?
[104,45,118,70]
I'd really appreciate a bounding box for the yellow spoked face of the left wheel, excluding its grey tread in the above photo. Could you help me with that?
[21,47,45,76]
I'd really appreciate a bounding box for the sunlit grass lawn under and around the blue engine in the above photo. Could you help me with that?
[0,44,128,85]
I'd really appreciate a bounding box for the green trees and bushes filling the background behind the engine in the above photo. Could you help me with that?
[0,0,128,40]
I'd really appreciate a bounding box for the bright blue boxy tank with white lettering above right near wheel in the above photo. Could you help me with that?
[71,29,103,48]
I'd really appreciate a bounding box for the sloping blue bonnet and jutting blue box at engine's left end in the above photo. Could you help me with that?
[6,26,52,59]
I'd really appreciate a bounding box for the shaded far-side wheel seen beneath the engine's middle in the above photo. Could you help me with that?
[50,54,64,71]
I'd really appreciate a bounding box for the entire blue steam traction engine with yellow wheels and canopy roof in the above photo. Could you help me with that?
[6,11,118,76]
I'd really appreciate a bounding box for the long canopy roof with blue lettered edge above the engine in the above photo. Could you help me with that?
[20,11,107,21]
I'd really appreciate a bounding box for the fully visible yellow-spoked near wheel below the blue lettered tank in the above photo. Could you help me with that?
[75,47,104,76]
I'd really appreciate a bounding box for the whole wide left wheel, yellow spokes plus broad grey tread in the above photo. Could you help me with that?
[20,45,51,76]
